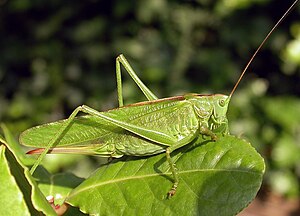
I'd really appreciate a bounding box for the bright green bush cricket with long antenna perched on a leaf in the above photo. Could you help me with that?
[20,0,298,197]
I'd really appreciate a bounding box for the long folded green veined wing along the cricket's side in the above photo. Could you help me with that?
[20,98,198,155]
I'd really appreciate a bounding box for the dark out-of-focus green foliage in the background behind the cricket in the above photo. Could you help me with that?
[0,0,300,196]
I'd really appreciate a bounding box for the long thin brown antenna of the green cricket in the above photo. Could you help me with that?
[229,0,299,98]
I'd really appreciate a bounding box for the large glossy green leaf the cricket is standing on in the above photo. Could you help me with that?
[66,136,265,215]
